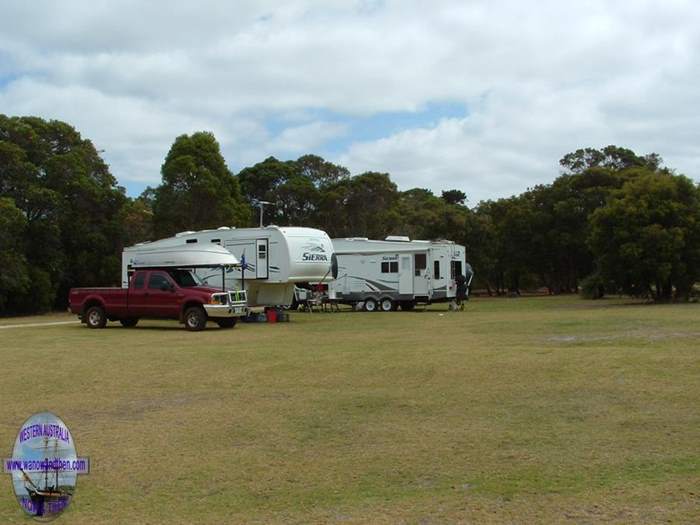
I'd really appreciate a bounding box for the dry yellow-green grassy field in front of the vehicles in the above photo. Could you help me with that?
[0,297,700,524]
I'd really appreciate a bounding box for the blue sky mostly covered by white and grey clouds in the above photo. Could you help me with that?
[0,0,700,204]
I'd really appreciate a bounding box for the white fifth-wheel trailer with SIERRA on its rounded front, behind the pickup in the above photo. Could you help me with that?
[122,226,337,306]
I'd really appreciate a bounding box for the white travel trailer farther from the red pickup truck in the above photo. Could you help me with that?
[328,236,472,311]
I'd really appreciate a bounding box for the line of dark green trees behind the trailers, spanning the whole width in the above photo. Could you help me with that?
[0,115,700,315]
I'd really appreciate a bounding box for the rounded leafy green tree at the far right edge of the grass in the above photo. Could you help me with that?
[590,167,700,301]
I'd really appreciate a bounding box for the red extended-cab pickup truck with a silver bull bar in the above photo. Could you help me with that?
[69,269,247,331]
